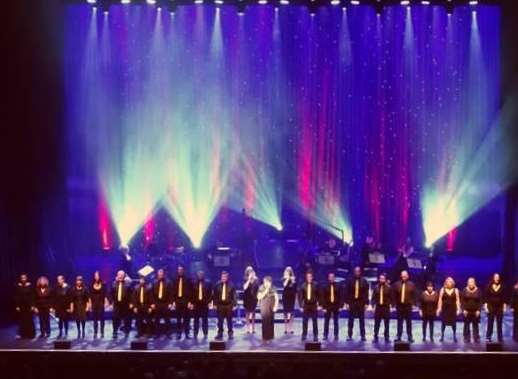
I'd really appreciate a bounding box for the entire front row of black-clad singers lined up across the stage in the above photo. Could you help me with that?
[11,266,518,343]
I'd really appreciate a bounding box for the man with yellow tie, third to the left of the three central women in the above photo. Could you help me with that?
[173,266,192,339]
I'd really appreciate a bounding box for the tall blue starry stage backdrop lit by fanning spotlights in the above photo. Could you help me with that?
[59,5,513,276]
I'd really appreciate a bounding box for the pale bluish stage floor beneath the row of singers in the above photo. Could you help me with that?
[0,315,518,353]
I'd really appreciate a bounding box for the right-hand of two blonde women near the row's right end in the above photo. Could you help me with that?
[460,278,482,343]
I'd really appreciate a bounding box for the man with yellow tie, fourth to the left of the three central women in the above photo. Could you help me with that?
[151,269,175,337]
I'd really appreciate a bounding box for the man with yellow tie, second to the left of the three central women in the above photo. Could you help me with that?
[192,270,212,338]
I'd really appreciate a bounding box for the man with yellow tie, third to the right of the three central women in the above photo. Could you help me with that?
[345,266,369,341]
